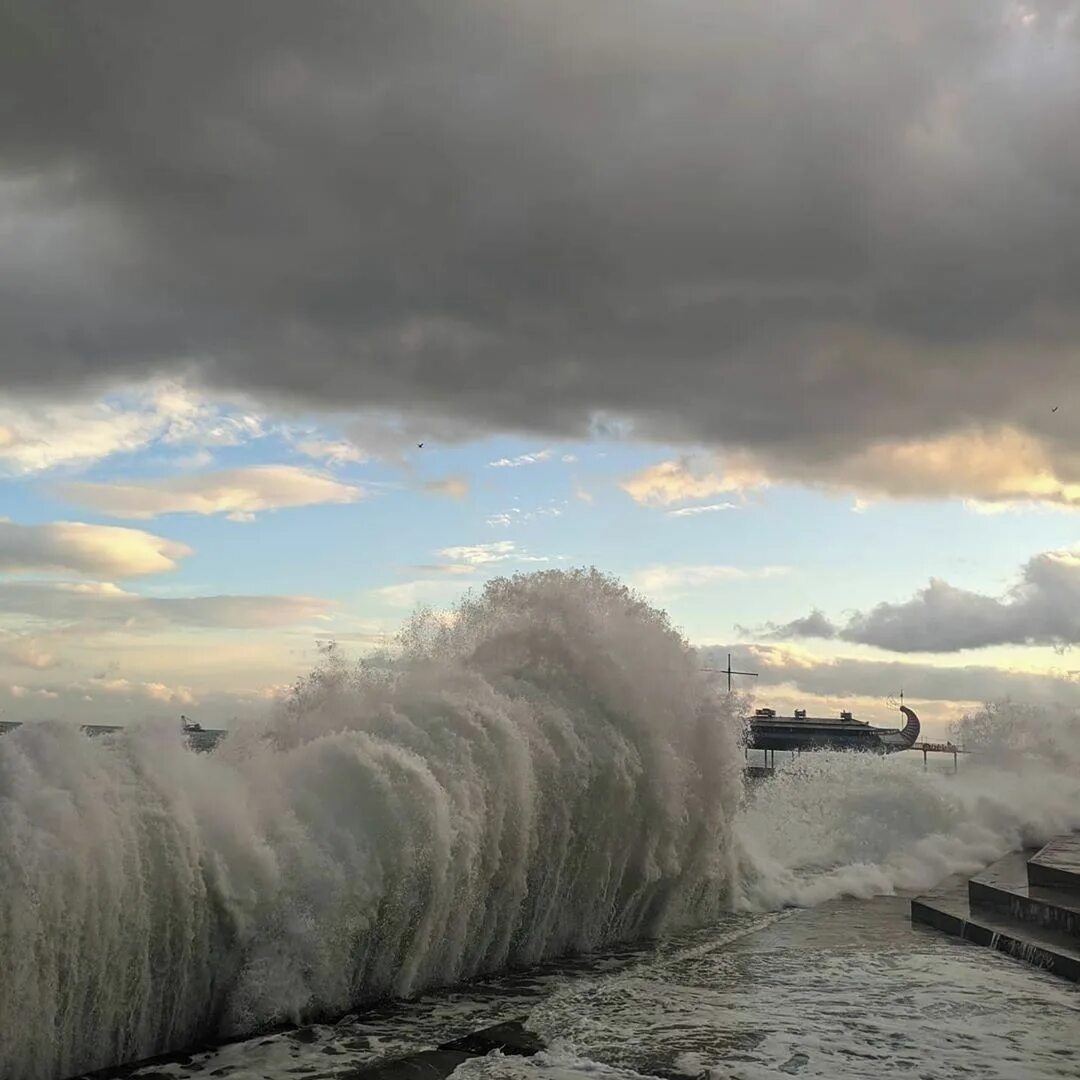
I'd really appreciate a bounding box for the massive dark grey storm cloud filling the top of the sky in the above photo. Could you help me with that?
[0,0,1080,457]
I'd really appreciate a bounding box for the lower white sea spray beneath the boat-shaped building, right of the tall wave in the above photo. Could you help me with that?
[734,702,1080,909]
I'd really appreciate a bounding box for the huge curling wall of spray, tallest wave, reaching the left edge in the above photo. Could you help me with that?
[0,571,742,1080]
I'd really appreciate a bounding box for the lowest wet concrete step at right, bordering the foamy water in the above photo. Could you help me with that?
[912,878,1080,983]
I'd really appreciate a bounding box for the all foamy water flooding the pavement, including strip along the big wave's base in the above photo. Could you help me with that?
[107,897,1080,1080]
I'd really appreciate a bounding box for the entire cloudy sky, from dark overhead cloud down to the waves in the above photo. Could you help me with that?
[0,0,1080,730]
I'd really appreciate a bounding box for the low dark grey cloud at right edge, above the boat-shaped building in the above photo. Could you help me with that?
[762,552,1080,652]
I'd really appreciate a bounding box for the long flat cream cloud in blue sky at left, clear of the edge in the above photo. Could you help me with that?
[56,465,365,521]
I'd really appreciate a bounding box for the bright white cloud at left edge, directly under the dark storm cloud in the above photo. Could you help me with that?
[0,382,264,475]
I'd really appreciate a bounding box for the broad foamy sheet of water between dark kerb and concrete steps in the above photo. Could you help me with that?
[455,897,1080,1080]
